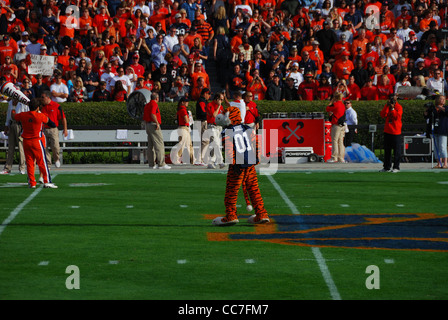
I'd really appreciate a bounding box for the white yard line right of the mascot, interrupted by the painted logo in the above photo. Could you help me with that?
[267,175,341,300]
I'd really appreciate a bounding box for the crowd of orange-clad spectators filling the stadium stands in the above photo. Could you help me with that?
[0,0,448,103]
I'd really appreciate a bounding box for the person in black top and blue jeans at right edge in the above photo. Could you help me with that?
[424,95,448,169]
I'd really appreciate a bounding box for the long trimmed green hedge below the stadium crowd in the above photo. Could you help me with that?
[0,100,428,127]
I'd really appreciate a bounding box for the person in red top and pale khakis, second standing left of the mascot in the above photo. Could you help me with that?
[170,97,195,164]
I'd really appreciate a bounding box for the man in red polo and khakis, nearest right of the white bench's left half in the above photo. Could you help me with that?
[143,92,171,169]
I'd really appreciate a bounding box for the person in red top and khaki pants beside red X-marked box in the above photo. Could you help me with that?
[327,92,345,163]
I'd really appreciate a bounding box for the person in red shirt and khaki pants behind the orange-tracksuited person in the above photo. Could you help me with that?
[42,91,68,168]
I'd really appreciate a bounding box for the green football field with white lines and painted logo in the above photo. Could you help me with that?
[0,170,448,301]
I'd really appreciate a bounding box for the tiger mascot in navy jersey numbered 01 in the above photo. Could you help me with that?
[213,107,270,226]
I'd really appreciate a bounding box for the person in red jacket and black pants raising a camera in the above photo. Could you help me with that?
[380,94,403,173]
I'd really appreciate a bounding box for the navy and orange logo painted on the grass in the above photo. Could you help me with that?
[207,213,448,252]
